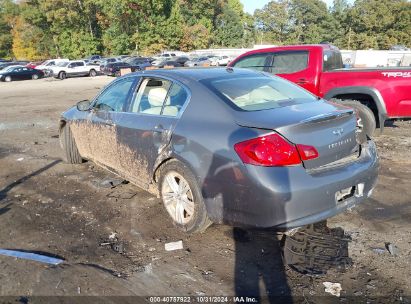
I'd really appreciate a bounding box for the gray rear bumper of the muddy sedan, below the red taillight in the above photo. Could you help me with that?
[211,141,379,229]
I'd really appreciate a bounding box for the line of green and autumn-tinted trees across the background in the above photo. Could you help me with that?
[0,0,411,60]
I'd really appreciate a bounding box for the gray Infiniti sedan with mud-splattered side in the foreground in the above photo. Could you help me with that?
[60,68,379,232]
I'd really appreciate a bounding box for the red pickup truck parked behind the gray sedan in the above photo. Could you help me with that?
[229,44,411,136]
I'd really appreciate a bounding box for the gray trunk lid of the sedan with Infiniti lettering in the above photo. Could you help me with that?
[235,101,359,169]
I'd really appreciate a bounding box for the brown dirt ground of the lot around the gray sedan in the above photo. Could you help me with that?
[0,76,411,303]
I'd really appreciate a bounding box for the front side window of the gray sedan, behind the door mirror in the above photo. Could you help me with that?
[94,77,135,112]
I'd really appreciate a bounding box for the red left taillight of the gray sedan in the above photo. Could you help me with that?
[234,133,318,167]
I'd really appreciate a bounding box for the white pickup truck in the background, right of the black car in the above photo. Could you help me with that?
[50,60,100,79]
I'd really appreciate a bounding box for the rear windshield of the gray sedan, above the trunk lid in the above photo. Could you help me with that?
[209,77,317,111]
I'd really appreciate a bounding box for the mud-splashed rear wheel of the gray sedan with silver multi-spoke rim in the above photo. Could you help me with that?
[159,160,212,233]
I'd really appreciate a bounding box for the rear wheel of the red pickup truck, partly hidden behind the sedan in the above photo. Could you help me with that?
[336,100,377,142]
